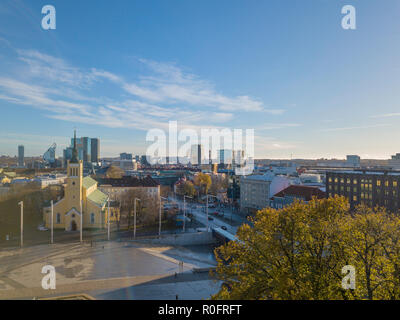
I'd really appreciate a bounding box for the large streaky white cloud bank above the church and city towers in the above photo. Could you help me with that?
[0,49,284,130]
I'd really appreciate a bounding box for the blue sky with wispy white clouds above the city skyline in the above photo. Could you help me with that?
[0,0,400,158]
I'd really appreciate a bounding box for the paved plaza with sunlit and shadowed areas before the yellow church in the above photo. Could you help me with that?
[0,241,220,300]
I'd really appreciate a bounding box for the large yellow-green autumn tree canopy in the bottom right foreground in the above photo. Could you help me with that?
[213,197,400,300]
